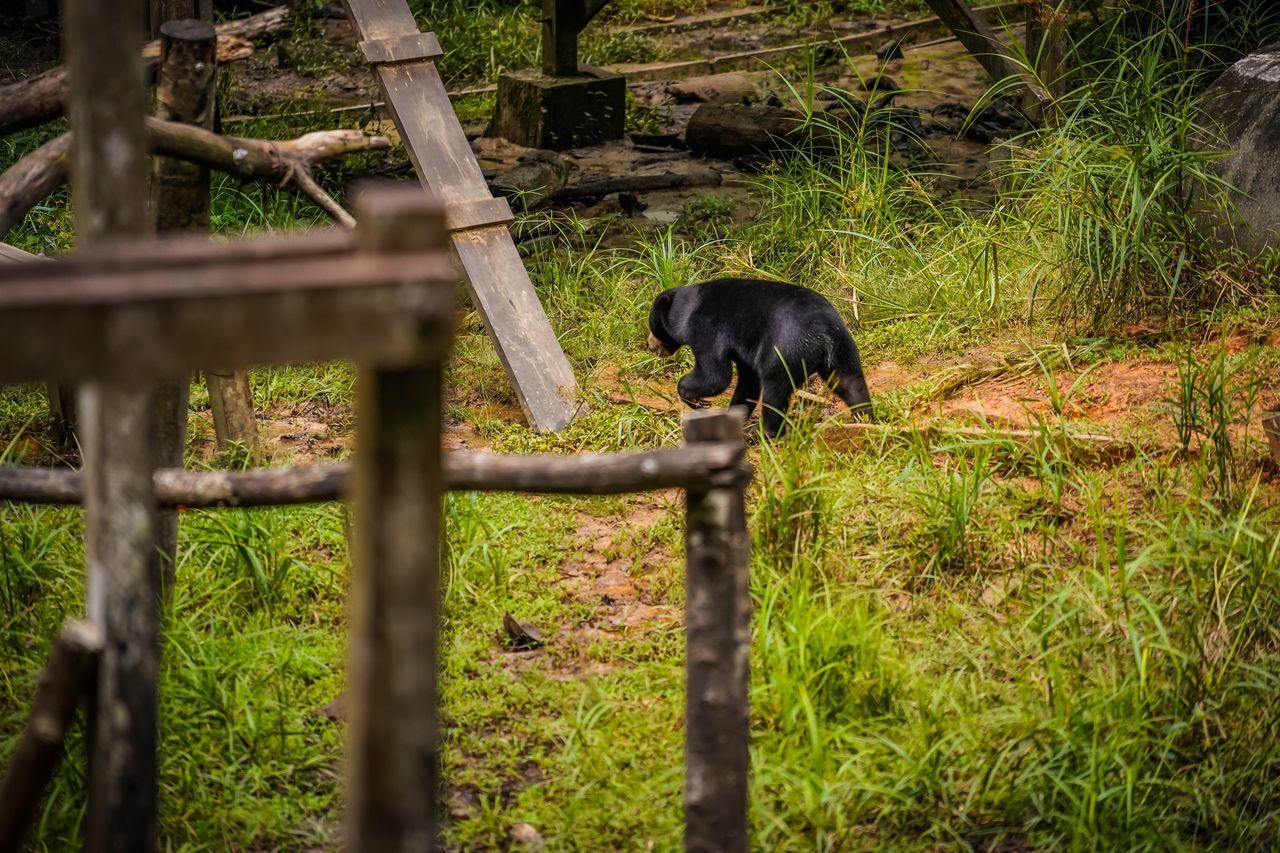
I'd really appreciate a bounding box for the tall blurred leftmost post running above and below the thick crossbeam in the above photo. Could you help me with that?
[63,0,159,853]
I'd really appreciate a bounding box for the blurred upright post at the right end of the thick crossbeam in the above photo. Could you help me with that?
[346,187,448,850]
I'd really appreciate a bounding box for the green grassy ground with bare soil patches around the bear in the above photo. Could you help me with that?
[0,1,1280,849]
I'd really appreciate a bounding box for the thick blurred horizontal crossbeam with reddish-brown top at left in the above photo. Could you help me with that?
[0,249,456,382]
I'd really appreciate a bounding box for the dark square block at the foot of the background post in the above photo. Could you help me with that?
[485,65,627,151]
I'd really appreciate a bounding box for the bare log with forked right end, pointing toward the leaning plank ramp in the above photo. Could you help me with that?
[0,118,390,236]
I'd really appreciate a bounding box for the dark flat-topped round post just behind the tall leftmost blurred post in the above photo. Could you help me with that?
[151,19,218,596]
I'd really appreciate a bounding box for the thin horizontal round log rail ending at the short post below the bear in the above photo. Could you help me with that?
[0,442,746,508]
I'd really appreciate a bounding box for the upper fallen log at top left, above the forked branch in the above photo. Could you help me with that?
[0,6,289,136]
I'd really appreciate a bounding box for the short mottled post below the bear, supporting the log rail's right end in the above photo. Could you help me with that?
[682,407,751,852]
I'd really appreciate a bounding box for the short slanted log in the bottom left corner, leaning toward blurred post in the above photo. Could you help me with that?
[0,622,102,853]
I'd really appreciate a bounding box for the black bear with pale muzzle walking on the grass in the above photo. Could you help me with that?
[649,278,872,438]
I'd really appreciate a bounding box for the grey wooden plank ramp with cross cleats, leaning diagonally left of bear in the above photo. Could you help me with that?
[344,0,577,432]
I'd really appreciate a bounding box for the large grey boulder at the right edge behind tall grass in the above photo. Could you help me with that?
[1197,42,1280,255]
